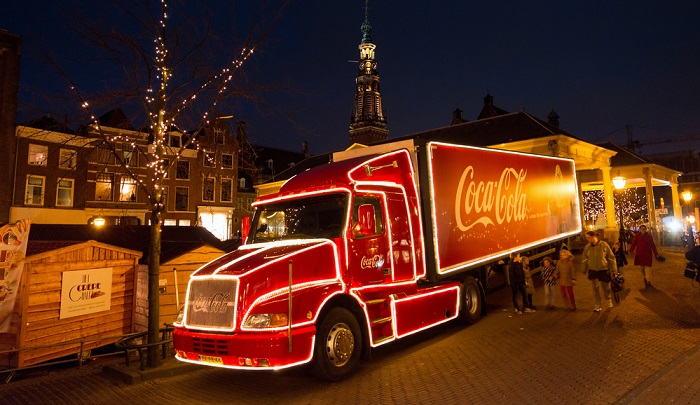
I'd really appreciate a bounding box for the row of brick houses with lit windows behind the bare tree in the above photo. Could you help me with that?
[10,109,239,240]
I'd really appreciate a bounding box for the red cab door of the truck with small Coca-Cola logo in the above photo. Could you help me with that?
[348,195,391,284]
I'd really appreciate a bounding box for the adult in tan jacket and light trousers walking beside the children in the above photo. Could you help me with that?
[581,231,617,312]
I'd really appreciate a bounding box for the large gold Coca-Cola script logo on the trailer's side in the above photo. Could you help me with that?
[455,166,527,232]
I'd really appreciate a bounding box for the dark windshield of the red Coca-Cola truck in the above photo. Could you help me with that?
[249,193,348,243]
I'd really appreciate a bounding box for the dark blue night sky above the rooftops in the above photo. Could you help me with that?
[0,0,700,154]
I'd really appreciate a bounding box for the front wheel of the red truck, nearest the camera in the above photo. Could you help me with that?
[311,308,362,381]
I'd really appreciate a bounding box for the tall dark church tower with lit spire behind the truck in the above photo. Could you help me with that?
[350,0,389,145]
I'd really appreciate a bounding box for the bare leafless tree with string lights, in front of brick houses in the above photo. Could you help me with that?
[56,0,287,367]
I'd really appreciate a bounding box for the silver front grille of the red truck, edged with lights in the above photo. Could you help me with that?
[185,278,237,331]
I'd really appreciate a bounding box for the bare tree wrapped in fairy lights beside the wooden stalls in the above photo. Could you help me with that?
[56,0,287,367]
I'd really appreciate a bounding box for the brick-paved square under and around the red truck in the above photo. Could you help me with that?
[0,248,700,404]
